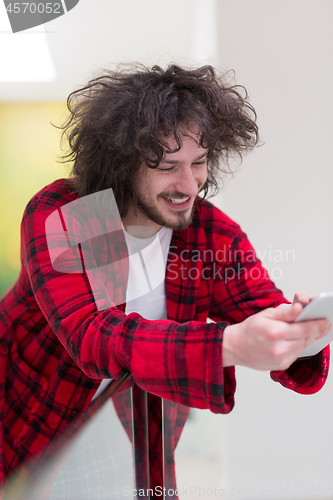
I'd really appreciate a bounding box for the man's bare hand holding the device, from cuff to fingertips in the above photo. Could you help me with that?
[223,300,331,370]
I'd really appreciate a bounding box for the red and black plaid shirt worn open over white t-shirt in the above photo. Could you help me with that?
[0,180,329,481]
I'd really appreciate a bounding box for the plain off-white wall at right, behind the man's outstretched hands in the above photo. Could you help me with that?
[213,0,333,498]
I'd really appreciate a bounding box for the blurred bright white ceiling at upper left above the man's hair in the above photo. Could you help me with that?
[0,0,216,102]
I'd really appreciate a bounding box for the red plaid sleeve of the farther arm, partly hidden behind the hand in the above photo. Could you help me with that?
[211,227,330,394]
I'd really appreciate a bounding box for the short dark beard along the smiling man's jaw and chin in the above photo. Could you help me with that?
[137,193,194,231]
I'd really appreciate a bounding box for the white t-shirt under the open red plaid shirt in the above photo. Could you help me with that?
[92,227,172,401]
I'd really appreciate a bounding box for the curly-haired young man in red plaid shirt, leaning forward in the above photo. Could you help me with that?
[0,62,329,485]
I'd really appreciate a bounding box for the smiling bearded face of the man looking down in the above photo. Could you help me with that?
[131,133,208,231]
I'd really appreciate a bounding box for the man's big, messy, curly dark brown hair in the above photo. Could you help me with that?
[60,65,259,217]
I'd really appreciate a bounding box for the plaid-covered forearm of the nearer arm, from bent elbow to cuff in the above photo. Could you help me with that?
[57,302,235,413]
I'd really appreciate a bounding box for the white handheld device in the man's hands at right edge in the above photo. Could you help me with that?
[295,292,333,358]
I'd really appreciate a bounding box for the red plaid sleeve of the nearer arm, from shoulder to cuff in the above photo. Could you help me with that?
[21,193,234,413]
